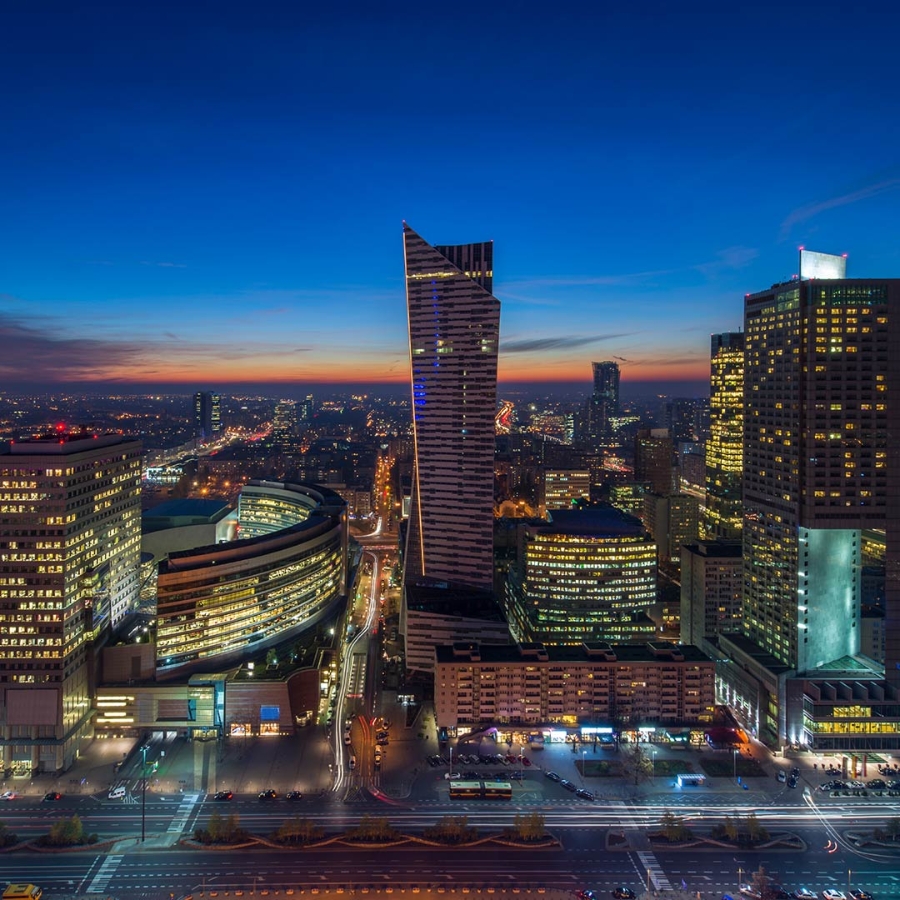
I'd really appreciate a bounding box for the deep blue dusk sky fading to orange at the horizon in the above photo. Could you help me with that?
[0,0,900,389]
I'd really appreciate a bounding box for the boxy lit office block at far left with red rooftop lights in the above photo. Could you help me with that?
[0,431,141,772]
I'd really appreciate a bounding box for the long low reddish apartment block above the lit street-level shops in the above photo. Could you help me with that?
[434,643,715,728]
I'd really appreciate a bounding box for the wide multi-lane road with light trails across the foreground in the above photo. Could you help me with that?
[0,794,900,900]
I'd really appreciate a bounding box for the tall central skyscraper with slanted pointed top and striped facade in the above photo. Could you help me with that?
[403,225,500,588]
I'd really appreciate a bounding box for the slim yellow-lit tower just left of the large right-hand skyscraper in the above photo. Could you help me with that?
[704,332,744,540]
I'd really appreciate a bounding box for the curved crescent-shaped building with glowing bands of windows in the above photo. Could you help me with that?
[156,482,347,677]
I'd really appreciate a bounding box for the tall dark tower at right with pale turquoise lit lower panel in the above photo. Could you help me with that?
[742,278,900,678]
